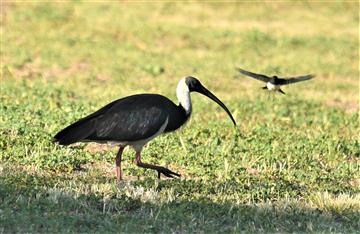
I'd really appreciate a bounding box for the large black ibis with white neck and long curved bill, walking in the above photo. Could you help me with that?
[54,76,236,181]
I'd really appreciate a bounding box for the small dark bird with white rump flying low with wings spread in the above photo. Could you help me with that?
[237,68,314,94]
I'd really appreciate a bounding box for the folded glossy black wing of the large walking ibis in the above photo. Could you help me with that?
[54,94,171,145]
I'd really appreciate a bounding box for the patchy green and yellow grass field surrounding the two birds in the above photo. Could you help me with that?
[0,1,360,233]
